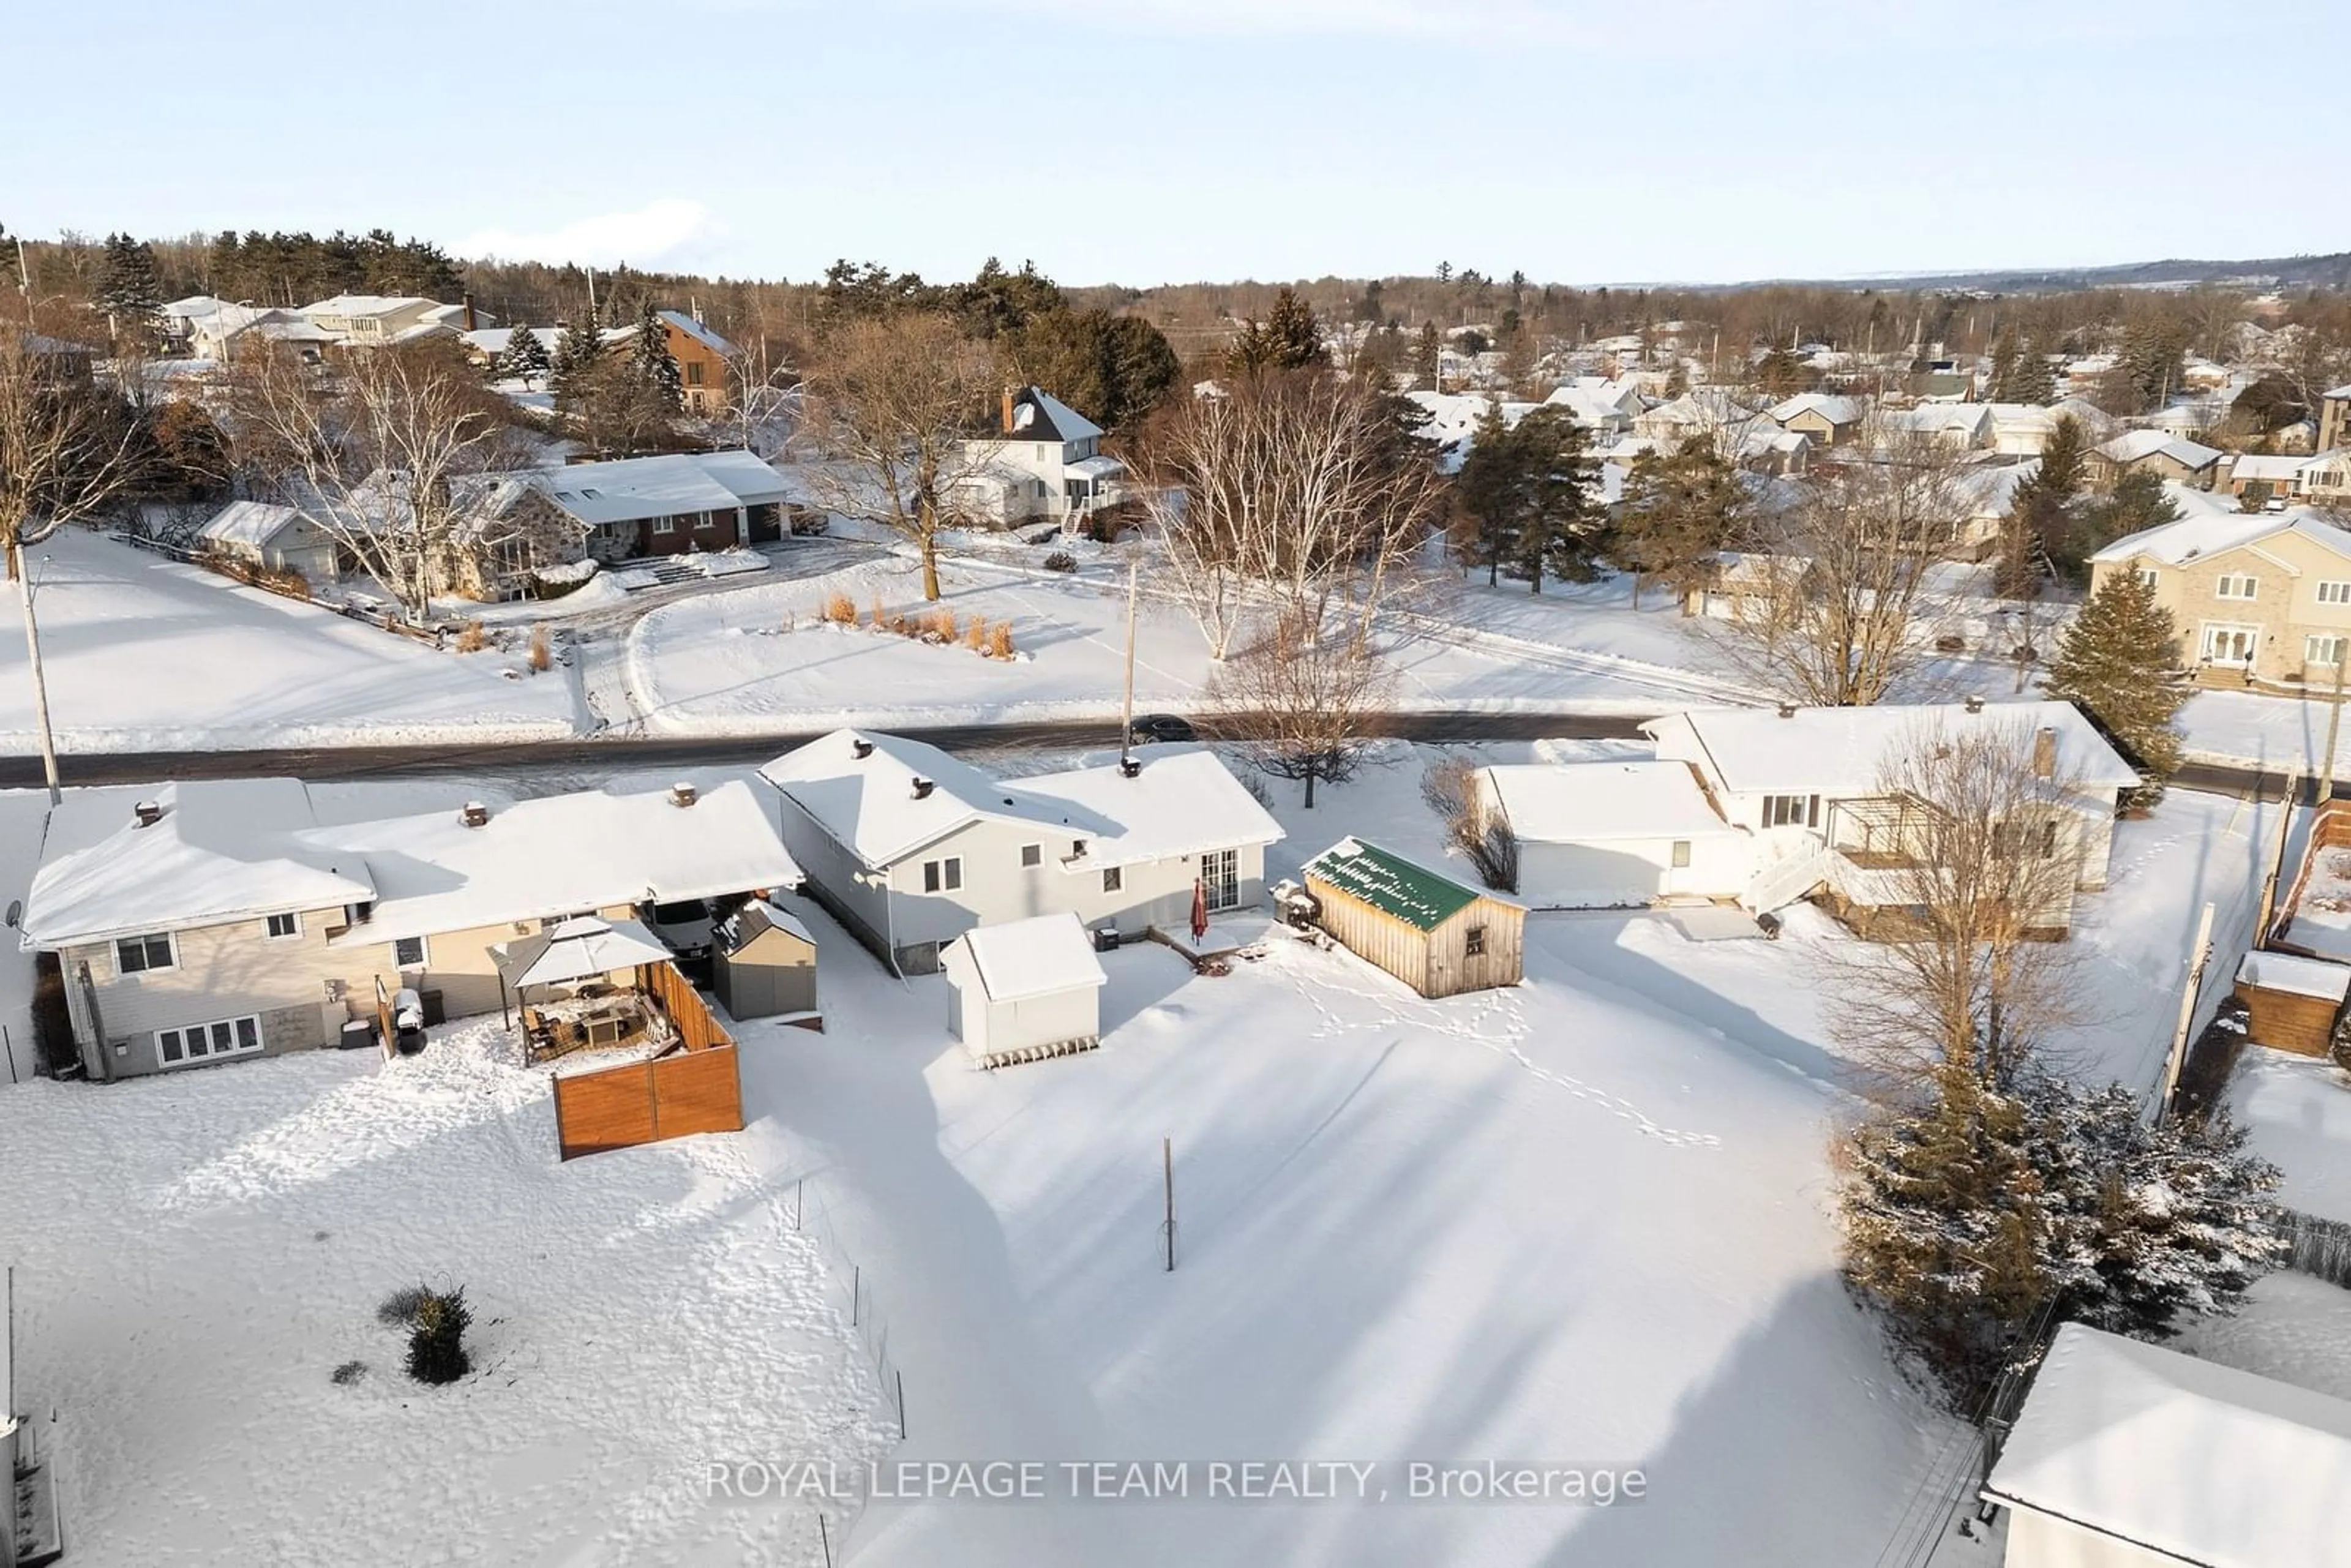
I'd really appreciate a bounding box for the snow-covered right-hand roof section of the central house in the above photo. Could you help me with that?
[1004,750,1281,868]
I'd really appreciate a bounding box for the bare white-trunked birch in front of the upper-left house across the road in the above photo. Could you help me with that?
[230,343,529,621]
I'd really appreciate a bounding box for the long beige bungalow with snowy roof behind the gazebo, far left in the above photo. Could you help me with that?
[19,778,800,1079]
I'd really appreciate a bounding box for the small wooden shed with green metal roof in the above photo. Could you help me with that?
[1305,839,1526,997]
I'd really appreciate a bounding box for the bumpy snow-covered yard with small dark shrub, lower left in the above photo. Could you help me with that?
[0,1020,896,1568]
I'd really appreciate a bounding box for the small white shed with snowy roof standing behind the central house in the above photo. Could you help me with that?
[938,912,1109,1067]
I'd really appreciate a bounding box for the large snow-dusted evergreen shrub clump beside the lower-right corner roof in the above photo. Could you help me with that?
[1839,1067,2283,1413]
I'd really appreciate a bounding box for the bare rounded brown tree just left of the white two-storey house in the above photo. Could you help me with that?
[800,310,1002,599]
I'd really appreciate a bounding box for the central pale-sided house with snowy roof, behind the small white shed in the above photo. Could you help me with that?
[759,729,1281,973]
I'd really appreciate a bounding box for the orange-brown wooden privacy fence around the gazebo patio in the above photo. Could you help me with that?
[555,964,743,1159]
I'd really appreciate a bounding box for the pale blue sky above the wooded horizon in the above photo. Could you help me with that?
[0,0,2351,285]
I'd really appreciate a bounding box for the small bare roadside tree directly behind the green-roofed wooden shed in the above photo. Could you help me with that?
[1209,611,1389,809]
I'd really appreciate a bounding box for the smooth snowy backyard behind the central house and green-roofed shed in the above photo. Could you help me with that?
[748,888,1949,1568]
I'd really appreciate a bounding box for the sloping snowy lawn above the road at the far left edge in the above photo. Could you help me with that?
[0,531,574,752]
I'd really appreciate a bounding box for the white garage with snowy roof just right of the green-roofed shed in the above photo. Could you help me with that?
[1479,762,1756,910]
